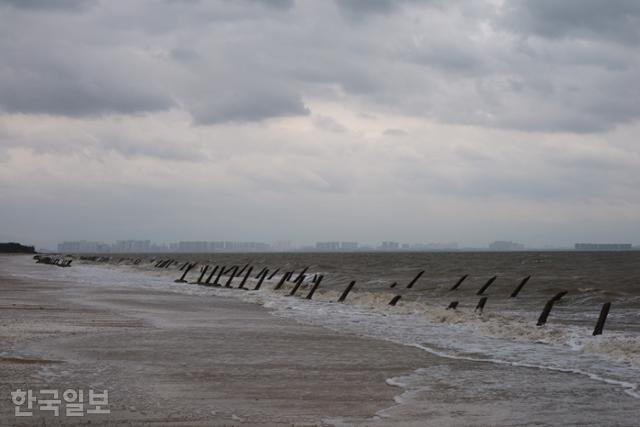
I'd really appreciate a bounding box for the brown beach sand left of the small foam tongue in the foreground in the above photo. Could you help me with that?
[0,257,432,425]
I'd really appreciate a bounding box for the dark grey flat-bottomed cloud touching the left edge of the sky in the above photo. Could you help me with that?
[0,42,173,116]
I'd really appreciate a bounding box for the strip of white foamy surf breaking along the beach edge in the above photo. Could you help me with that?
[11,258,640,404]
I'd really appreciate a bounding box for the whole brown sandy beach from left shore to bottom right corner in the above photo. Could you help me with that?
[0,256,638,426]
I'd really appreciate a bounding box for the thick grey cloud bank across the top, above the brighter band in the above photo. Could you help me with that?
[0,0,640,133]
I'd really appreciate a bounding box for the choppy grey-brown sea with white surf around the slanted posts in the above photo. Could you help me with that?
[12,252,640,425]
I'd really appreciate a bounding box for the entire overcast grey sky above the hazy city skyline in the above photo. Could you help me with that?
[0,0,640,248]
